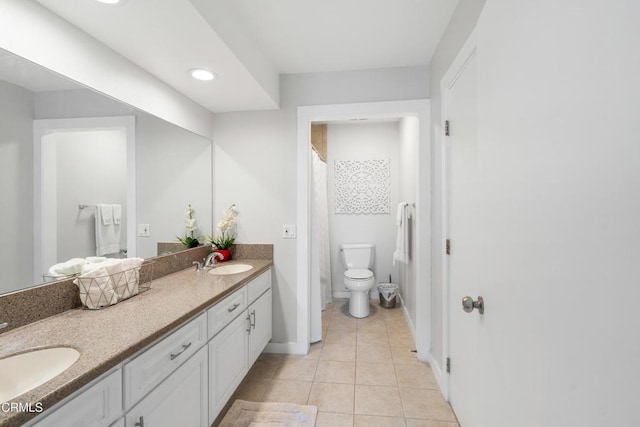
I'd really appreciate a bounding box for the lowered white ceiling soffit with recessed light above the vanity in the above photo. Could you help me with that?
[37,0,278,112]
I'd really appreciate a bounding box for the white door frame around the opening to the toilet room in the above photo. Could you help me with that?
[298,99,431,362]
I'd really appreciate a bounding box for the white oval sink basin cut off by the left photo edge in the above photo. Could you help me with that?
[0,347,80,402]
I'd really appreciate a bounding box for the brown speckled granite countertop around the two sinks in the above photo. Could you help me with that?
[0,259,273,427]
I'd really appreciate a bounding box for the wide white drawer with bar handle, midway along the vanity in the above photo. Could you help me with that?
[124,313,207,409]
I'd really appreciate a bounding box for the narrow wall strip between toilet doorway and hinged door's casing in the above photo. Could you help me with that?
[429,0,485,367]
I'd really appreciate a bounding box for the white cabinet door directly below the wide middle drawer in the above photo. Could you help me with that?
[125,347,209,427]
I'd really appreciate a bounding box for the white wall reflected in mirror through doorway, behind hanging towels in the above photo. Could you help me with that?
[52,129,127,262]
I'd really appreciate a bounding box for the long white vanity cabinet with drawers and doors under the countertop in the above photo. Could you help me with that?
[23,269,272,427]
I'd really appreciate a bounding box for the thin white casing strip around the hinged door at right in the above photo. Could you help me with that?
[436,29,477,401]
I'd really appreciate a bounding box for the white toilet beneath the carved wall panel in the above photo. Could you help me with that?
[340,243,376,318]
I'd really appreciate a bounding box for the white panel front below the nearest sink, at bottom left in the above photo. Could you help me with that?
[34,369,122,427]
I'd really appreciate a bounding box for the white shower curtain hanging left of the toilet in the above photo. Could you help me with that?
[311,150,332,342]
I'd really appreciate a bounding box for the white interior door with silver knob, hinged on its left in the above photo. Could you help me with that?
[445,49,483,427]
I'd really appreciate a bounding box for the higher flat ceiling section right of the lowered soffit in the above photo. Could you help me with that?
[200,0,458,73]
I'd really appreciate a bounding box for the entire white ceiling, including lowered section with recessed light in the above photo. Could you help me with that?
[36,0,458,112]
